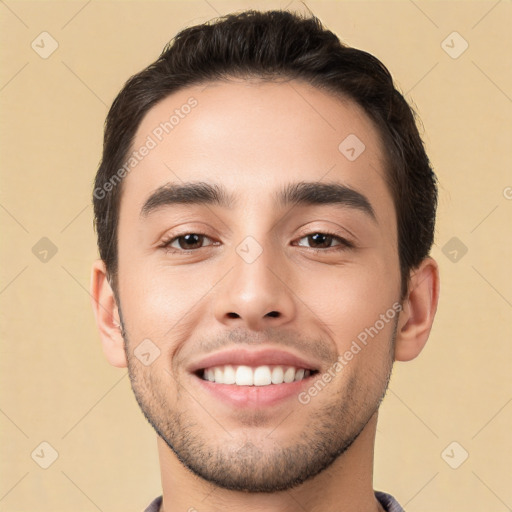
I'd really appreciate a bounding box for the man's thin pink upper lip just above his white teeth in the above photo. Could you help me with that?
[188,348,319,373]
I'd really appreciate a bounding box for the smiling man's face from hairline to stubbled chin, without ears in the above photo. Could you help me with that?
[118,81,400,492]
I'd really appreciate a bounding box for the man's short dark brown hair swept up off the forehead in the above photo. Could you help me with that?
[93,10,437,297]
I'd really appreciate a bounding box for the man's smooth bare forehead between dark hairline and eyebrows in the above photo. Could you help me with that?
[121,80,393,219]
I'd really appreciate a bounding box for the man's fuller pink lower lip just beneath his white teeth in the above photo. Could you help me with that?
[192,374,317,407]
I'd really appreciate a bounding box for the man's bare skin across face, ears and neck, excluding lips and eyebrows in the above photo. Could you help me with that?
[91,80,439,512]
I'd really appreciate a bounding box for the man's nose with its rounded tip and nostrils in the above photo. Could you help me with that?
[215,243,296,331]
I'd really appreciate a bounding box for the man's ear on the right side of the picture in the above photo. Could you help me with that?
[395,257,439,361]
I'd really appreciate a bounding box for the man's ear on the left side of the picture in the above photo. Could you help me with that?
[91,260,128,368]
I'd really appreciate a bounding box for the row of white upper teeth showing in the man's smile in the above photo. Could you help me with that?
[203,364,311,386]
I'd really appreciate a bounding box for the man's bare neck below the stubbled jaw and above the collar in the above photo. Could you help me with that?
[157,412,384,512]
